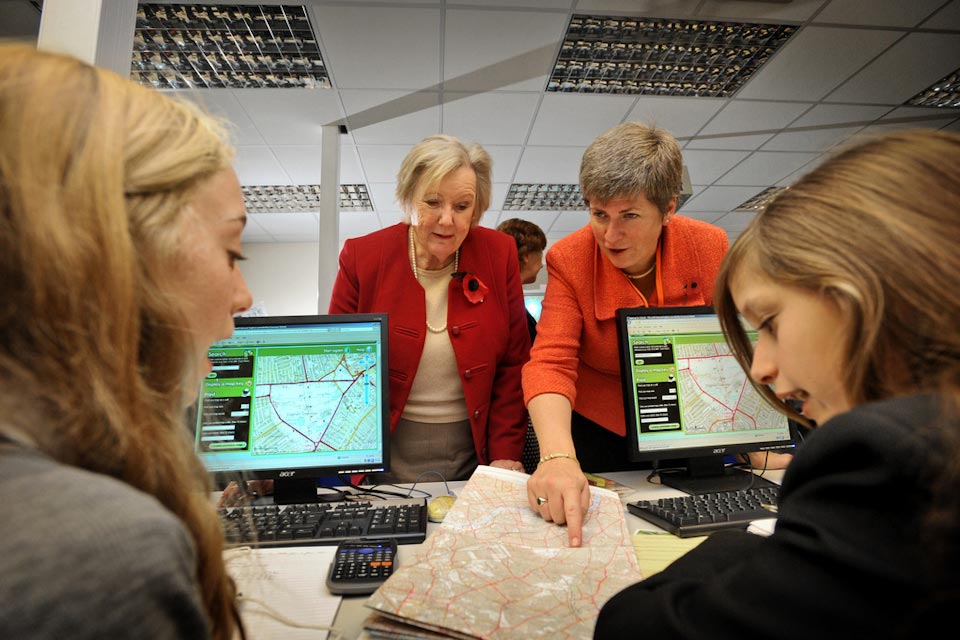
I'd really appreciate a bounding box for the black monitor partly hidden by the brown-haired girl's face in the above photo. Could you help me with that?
[617,307,795,494]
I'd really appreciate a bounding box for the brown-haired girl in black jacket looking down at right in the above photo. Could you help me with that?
[595,130,960,640]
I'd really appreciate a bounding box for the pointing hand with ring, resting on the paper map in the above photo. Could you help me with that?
[527,458,590,547]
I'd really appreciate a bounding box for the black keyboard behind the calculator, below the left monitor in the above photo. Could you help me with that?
[219,498,427,547]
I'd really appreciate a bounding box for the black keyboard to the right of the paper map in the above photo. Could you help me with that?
[627,486,780,538]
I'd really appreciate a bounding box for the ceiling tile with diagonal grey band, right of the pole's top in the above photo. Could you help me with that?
[340,90,440,145]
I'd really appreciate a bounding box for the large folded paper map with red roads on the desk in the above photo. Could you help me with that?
[367,466,641,640]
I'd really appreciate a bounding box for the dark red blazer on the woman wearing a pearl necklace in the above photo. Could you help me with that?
[330,223,530,464]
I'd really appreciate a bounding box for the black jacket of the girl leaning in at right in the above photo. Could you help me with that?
[595,400,929,640]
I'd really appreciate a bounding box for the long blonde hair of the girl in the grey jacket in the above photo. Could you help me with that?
[0,45,239,638]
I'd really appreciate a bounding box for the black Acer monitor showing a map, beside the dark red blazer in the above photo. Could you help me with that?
[195,314,390,504]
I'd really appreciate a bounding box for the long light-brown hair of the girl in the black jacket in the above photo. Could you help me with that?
[714,129,960,568]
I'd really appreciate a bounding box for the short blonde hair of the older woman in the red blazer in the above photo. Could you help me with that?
[397,134,493,226]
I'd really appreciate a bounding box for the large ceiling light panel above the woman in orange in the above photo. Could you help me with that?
[547,15,797,98]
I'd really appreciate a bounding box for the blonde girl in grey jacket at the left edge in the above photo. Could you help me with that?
[0,45,252,640]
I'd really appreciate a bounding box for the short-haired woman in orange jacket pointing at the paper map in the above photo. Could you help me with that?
[523,122,728,546]
